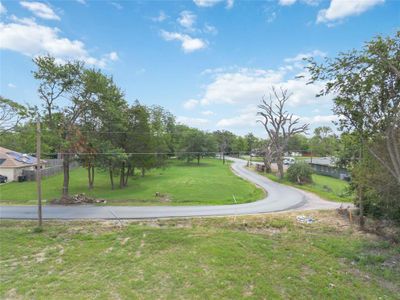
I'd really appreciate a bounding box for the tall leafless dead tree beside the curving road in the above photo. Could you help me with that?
[258,87,308,178]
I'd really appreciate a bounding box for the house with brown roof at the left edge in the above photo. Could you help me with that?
[0,147,46,181]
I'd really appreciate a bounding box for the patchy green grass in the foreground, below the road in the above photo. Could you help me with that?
[0,212,400,299]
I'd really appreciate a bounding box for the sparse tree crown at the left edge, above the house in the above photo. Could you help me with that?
[0,96,28,135]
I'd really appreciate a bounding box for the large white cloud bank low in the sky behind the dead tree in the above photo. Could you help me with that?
[190,50,336,131]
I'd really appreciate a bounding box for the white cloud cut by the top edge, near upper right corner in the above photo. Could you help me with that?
[317,0,385,23]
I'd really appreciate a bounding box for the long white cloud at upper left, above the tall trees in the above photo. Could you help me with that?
[0,16,118,67]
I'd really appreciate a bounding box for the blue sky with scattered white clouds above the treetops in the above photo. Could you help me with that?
[0,0,400,136]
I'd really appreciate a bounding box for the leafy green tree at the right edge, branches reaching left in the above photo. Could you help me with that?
[308,31,400,184]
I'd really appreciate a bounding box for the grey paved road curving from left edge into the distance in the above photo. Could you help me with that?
[0,158,340,219]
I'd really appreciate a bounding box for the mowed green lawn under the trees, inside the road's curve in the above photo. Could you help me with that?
[0,159,264,205]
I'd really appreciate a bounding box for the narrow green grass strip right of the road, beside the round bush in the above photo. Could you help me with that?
[255,168,353,202]
